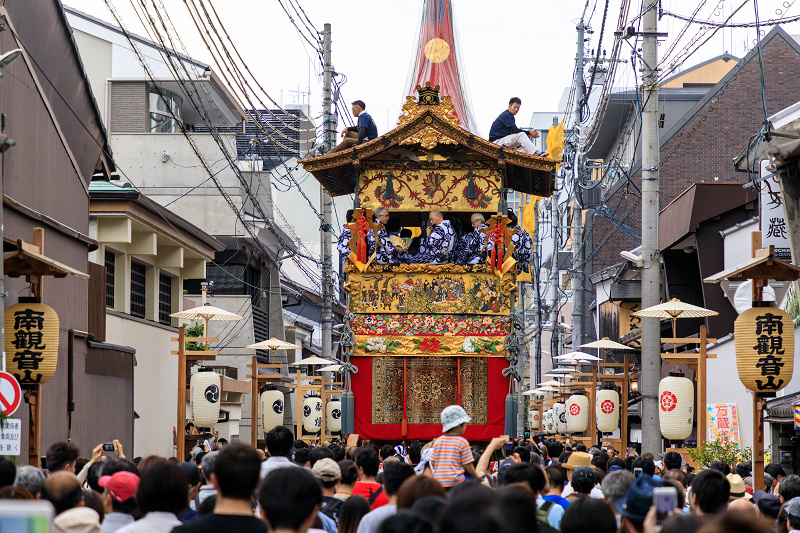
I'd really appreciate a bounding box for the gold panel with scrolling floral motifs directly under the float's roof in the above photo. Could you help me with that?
[359,168,500,211]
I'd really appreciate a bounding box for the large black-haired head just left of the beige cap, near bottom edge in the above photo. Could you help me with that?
[258,468,322,530]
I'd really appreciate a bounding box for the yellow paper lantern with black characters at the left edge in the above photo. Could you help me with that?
[5,298,58,385]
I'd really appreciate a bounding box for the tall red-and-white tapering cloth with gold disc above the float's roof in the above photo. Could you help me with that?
[406,0,478,133]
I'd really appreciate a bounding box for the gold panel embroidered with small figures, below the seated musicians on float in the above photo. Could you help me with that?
[345,272,517,315]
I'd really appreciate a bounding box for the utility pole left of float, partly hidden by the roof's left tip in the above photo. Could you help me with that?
[320,23,336,359]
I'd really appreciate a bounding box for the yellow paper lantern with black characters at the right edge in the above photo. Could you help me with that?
[733,307,794,396]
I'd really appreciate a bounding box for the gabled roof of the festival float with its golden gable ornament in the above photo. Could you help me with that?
[302,82,558,196]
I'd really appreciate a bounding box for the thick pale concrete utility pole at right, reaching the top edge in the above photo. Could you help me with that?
[640,0,664,454]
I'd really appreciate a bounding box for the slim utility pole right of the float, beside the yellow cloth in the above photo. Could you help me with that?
[572,20,586,351]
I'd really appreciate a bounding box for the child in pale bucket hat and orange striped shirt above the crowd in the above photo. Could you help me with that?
[430,405,479,489]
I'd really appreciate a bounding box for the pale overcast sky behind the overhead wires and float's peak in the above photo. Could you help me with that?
[66,0,800,136]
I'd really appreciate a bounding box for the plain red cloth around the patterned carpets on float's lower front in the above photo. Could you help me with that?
[351,357,509,442]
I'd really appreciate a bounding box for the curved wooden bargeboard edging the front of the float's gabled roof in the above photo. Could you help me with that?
[301,109,558,177]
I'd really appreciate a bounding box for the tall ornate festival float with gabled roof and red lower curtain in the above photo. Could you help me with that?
[302,0,557,441]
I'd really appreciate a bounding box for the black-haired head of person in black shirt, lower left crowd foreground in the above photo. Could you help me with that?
[214,442,260,500]
